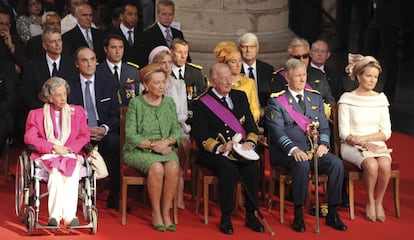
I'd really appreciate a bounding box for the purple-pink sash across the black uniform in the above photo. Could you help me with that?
[200,94,246,139]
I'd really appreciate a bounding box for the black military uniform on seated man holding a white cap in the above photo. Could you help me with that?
[191,88,258,215]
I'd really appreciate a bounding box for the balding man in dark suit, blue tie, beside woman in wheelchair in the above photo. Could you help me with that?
[68,47,120,209]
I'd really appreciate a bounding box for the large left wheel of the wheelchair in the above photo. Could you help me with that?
[15,151,29,222]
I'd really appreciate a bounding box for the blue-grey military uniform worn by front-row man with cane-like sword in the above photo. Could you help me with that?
[266,89,344,206]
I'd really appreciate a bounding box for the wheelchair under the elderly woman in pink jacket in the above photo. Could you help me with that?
[15,149,98,235]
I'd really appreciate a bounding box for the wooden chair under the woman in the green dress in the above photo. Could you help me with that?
[120,106,178,225]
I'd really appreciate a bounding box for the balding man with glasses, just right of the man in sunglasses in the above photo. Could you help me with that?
[310,39,345,101]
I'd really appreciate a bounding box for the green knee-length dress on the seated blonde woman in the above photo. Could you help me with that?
[123,95,181,174]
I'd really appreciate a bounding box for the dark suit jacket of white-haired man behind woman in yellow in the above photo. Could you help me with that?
[241,59,275,107]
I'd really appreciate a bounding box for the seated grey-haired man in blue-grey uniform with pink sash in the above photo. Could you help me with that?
[266,58,347,232]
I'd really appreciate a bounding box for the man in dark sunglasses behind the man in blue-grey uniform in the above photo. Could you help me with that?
[271,37,335,103]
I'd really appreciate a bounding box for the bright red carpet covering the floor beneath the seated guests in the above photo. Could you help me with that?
[0,133,414,240]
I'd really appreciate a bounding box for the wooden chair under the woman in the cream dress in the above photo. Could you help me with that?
[332,105,400,220]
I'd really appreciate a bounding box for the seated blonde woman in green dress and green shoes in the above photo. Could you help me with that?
[124,64,181,231]
